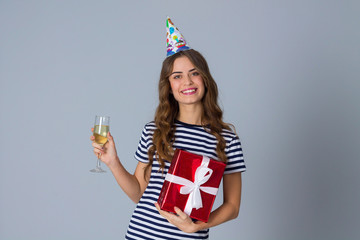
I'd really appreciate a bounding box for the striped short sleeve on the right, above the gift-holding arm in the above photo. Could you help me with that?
[224,135,246,174]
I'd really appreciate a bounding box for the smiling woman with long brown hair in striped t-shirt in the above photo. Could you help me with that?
[91,17,245,239]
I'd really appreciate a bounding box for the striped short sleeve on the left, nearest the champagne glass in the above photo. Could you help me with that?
[135,123,155,163]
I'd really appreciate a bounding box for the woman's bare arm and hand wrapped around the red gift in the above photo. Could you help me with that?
[155,172,241,233]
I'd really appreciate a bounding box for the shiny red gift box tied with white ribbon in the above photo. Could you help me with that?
[158,149,226,222]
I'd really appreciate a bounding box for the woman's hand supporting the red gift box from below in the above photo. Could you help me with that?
[155,202,206,233]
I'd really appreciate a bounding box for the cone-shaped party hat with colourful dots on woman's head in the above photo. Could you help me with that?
[166,17,190,56]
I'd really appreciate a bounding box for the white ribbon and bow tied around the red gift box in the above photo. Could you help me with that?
[165,156,218,215]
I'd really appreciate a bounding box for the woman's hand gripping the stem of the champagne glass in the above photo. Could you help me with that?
[90,128,119,168]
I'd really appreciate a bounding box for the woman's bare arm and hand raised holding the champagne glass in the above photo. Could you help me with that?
[90,130,151,203]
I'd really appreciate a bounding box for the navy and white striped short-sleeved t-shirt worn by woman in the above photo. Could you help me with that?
[125,121,246,240]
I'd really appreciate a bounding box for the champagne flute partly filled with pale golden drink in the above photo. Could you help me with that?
[90,116,110,173]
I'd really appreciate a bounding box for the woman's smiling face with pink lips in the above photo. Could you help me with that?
[169,56,205,105]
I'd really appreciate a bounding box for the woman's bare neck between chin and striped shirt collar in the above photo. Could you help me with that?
[178,104,203,125]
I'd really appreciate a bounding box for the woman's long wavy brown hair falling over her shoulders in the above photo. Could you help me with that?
[145,49,233,172]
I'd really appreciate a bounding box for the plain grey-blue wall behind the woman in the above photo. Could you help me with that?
[0,0,360,240]
